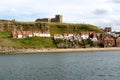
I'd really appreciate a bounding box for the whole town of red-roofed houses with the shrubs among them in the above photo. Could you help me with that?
[12,27,120,48]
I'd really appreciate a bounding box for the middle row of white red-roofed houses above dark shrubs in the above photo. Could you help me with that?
[54,32,98,41]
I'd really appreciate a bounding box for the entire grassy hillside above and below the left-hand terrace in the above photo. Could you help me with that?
[0,20,102,48]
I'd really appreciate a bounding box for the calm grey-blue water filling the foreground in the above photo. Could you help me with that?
[0,51,120,80]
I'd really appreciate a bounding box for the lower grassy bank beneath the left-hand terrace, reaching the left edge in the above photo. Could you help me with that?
[0,32,55,48]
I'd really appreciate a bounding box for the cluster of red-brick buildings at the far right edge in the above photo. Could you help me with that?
[101,27,120,47]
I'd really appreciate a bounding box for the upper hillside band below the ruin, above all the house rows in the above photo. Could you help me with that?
[0,20,101,34]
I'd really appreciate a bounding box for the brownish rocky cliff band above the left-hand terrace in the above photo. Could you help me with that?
[0,20,50,31]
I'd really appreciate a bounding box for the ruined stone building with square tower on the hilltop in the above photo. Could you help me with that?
[36,15,63,23]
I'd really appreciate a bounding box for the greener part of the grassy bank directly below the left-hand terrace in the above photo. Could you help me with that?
[11,37,55,48]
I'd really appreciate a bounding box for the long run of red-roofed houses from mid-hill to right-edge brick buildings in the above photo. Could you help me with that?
[54,32,120,47]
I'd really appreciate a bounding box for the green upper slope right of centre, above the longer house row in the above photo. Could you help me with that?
[48,23,102,35]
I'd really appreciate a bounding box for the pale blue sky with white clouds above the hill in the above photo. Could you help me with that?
[0,0,120,31]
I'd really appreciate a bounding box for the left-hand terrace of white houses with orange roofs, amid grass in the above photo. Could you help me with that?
[12,30,51,38]
